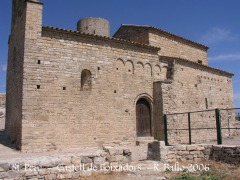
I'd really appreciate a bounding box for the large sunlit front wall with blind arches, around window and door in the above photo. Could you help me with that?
[15,0,166,152]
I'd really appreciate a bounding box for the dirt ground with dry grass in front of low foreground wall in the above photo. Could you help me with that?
[82,160,240,180]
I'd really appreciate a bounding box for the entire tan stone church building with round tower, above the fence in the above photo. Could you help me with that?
[5,0,233,152]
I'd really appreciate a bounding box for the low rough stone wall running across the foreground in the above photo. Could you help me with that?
[0,142,240,180]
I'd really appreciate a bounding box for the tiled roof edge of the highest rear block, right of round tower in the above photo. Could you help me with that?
[121,24,209,50]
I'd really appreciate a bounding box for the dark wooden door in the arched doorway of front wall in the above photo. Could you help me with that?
[136,98,152,137]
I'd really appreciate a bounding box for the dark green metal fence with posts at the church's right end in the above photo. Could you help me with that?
[164,108,240,145]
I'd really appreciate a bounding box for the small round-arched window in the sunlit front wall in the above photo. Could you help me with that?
[81,69,92,91]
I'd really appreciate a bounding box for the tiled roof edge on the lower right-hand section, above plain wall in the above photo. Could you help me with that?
[160,56,234,77]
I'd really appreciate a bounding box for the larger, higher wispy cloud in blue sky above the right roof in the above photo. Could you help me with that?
[200,28,238,45]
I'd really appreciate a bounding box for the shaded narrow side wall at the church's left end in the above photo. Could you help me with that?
[5,0,30,147]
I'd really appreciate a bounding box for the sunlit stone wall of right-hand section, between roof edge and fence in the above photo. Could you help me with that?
[173,60,233,112]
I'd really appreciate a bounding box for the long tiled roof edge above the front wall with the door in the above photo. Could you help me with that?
[42,26,160,51]
